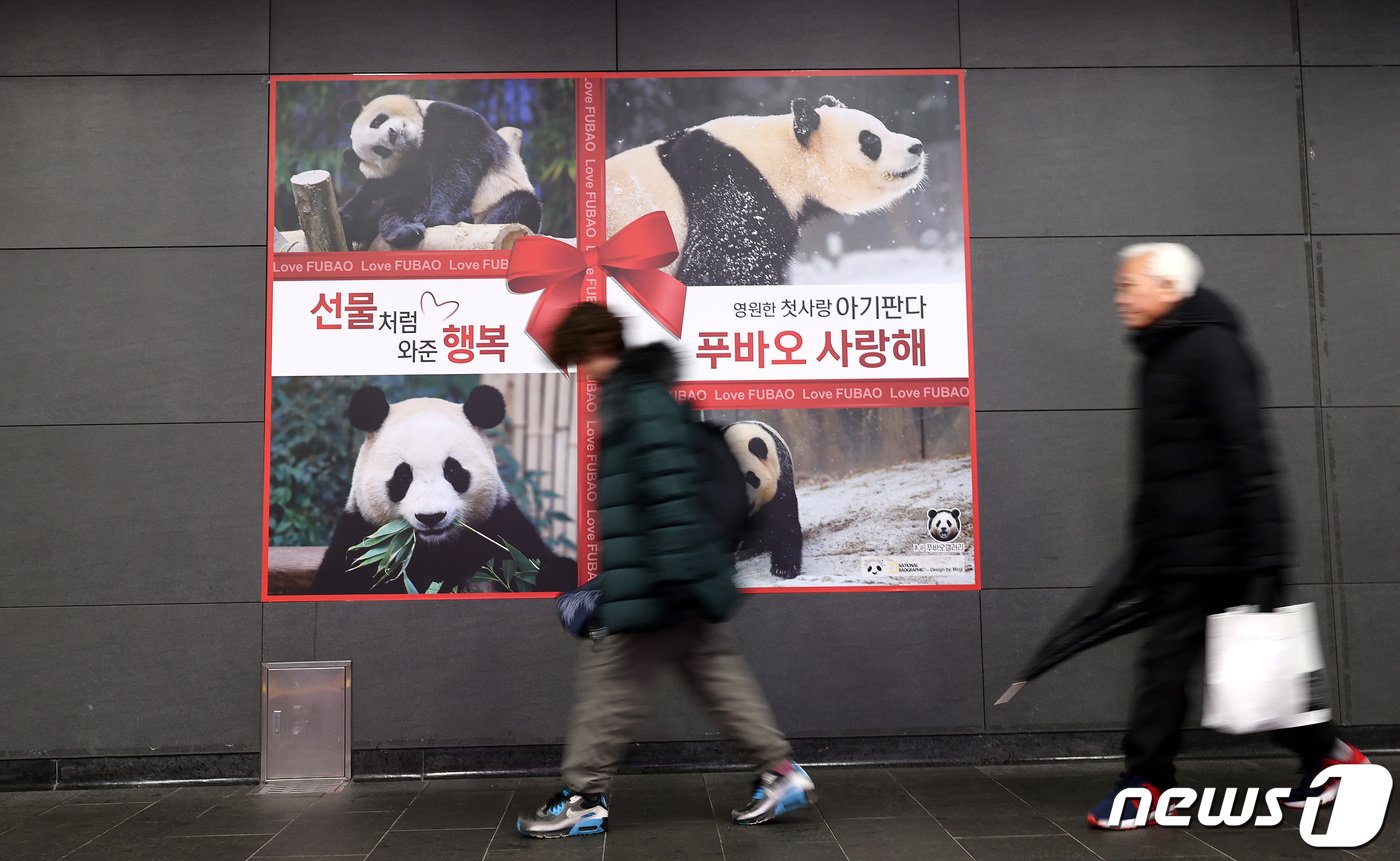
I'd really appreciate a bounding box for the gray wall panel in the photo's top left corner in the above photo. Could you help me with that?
[0,0,267,74]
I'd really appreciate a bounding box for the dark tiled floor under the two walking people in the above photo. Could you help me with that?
[0,756,1400,861]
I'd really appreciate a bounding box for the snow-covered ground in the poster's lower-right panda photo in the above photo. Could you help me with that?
[735,455,976,588]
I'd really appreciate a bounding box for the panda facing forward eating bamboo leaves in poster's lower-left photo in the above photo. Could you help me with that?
[312,385,578,595]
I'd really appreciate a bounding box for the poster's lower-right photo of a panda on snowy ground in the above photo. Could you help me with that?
[686,408,977,589]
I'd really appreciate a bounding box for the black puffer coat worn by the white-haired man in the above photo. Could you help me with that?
[1133,287,1288,575]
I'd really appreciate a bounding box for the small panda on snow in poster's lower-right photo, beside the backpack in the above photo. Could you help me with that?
[724,420,802,580]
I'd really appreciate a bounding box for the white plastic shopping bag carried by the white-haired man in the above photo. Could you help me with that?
[1201,603,1331,735]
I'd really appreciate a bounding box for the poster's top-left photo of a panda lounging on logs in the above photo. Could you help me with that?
[269,76,578,252]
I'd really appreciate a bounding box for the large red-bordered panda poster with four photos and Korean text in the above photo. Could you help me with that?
[263,70,980,601]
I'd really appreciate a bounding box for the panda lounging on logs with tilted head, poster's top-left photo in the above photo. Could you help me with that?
[340,95,542,248]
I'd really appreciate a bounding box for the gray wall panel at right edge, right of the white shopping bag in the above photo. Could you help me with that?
[1340,582,1400,724]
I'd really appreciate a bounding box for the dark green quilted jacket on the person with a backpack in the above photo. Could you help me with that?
[598,343,738,634]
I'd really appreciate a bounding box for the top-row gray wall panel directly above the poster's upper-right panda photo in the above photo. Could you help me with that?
[617,0,959,71]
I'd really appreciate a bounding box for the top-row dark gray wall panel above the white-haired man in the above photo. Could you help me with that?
[959,0,1298,69]
